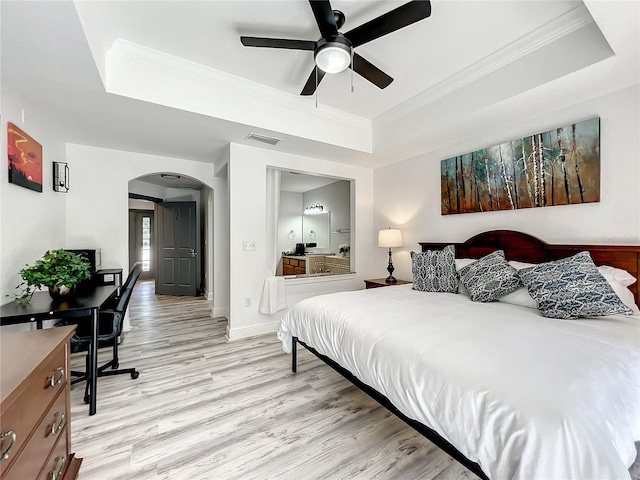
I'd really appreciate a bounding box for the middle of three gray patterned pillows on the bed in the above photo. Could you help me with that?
[458,250,522,302]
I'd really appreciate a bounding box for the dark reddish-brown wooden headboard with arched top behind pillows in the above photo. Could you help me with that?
[420,230,640,306]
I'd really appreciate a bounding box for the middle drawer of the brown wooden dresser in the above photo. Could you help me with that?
[3,391,69,480]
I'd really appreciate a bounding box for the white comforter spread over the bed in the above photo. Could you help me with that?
[278,285,640,480]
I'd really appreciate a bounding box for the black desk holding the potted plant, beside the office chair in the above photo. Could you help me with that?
[0,285,118,415]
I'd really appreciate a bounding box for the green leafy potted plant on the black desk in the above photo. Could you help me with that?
[17,248,91,303]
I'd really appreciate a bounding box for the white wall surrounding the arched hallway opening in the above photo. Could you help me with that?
[66,144,229,312]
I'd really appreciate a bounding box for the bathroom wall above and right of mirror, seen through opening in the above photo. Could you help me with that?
[302,180,351,255]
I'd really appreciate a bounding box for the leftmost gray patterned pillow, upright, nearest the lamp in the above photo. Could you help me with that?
[411,245,458,293]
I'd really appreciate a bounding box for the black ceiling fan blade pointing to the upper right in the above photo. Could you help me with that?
[344,0,431,47]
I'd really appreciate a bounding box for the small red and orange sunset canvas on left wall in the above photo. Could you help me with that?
[7,123,42,192]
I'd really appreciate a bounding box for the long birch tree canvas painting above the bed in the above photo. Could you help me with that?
[440,118,600,215]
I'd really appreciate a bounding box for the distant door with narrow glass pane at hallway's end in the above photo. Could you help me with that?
[129,209,157,280]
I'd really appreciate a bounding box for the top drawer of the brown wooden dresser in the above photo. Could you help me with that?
[0,345,69,479]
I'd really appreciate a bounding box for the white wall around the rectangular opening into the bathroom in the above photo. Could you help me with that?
[227,144,375,340]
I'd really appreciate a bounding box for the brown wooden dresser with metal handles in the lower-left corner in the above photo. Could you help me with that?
[0,326,82,480]
